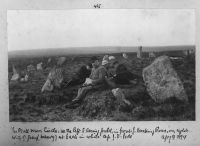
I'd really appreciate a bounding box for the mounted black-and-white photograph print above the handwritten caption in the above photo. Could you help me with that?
[7,9,196,122]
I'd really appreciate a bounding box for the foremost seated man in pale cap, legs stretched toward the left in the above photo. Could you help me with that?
[68,56,109,104]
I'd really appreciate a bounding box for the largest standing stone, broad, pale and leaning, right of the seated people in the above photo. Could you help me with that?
[143,56,188,103]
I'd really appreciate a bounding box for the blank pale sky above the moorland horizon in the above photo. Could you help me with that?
[7,9,195,51]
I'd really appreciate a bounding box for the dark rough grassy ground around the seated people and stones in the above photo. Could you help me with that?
[9,54,195,121]
